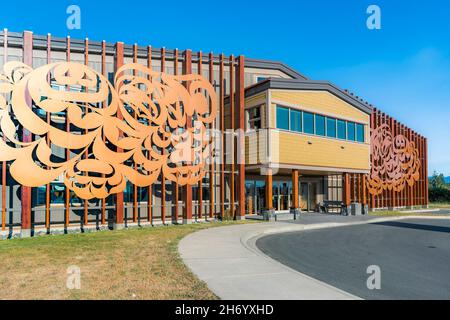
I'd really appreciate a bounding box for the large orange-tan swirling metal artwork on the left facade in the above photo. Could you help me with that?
[0,62,217,200]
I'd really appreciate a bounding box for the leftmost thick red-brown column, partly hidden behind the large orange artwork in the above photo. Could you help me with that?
[20,31,33,238]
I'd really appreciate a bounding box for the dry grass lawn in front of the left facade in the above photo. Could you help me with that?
[0,222,251,299]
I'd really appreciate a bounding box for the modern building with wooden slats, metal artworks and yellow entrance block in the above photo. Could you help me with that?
[0,30,428,235]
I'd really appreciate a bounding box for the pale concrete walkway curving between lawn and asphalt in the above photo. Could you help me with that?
[179,215,448,300]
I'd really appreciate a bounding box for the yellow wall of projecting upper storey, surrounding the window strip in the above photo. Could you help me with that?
[270,90,370,172]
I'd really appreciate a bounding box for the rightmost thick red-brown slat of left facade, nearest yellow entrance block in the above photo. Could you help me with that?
[236,55,244,219]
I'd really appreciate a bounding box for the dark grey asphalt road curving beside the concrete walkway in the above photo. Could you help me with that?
[255,219,450,300]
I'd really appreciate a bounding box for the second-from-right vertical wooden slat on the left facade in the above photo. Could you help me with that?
[228,55,239,219]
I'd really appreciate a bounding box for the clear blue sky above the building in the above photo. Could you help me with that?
[0,0,450,176]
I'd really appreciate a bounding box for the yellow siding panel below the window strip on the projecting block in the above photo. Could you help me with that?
[271,130,370,170]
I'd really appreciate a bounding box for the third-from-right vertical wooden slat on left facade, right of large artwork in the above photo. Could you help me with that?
[219,53,225,217]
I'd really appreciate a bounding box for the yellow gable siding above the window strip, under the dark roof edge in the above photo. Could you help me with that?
[271,90,370,124]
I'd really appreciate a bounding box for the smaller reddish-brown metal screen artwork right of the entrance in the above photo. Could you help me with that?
[368,124,421,195]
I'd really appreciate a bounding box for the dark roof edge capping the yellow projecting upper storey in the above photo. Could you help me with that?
[245,78,372,115]
